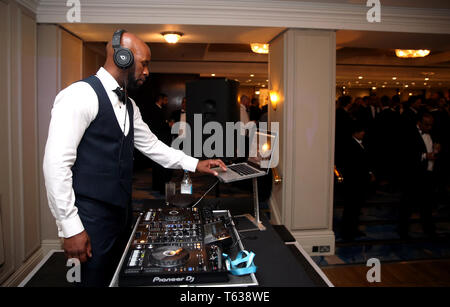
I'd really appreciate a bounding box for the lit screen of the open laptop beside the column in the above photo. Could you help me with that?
[248,130,277,172]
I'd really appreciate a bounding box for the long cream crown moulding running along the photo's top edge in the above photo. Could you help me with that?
[36,0,450,34]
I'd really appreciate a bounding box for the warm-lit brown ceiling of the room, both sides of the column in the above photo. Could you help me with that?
[61,23,450,88]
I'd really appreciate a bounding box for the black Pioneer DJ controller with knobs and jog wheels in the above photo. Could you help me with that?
[118,207,236,286]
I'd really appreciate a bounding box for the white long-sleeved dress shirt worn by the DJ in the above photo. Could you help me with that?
[43,67,198,238]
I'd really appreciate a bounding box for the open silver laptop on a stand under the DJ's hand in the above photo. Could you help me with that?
[213,129,278,183]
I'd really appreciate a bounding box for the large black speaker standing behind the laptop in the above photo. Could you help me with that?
[186,78,240,158]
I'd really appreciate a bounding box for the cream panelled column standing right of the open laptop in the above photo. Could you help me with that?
[269,29,336,255]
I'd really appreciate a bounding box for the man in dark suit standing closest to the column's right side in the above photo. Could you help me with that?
[341,121,375,240]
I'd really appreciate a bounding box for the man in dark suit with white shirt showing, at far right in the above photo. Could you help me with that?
[398,113,440,238]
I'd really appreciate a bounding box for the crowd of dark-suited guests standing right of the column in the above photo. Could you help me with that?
[335,93,450,240]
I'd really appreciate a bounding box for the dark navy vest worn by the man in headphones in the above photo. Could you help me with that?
[72,76,134,208]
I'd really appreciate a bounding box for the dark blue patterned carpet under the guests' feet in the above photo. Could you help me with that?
[313,191,450,267]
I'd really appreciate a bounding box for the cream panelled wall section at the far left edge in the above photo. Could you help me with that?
[0,0,41,282]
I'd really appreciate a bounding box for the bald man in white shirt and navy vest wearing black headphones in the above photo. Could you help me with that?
[44,30,226,286]
